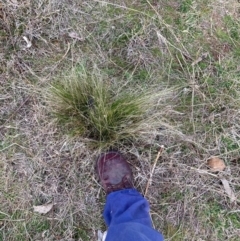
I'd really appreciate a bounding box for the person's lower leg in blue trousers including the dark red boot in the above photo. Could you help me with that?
[97,152,163,241]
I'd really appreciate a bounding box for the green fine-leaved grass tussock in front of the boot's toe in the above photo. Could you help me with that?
[49,66,170,146]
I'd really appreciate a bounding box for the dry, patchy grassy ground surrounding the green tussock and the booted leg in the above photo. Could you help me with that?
[0,0,240,241]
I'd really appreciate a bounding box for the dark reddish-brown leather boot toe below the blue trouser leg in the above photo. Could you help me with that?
[97,151,134,194]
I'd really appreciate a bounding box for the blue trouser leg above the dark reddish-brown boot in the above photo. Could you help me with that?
[103,189,163,241]
